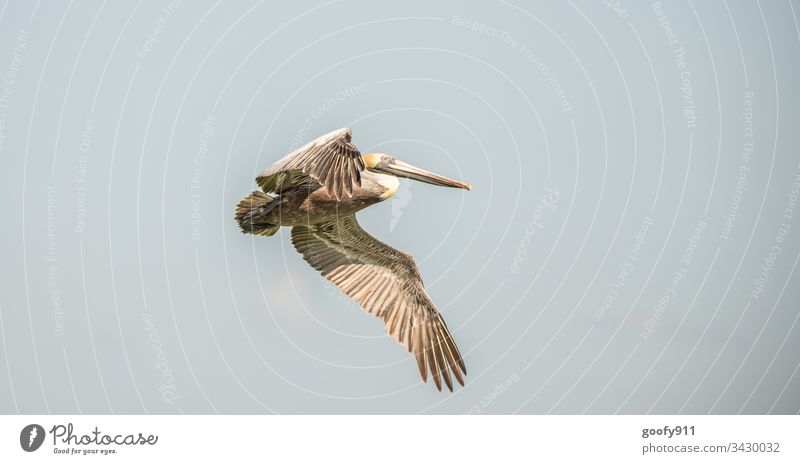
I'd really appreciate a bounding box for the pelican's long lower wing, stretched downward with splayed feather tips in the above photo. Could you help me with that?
[292,215,467,391]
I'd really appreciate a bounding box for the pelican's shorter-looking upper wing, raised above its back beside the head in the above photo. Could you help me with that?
[256,128,364,200]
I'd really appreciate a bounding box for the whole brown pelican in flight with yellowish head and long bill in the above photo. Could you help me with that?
[235,128,471,391]
